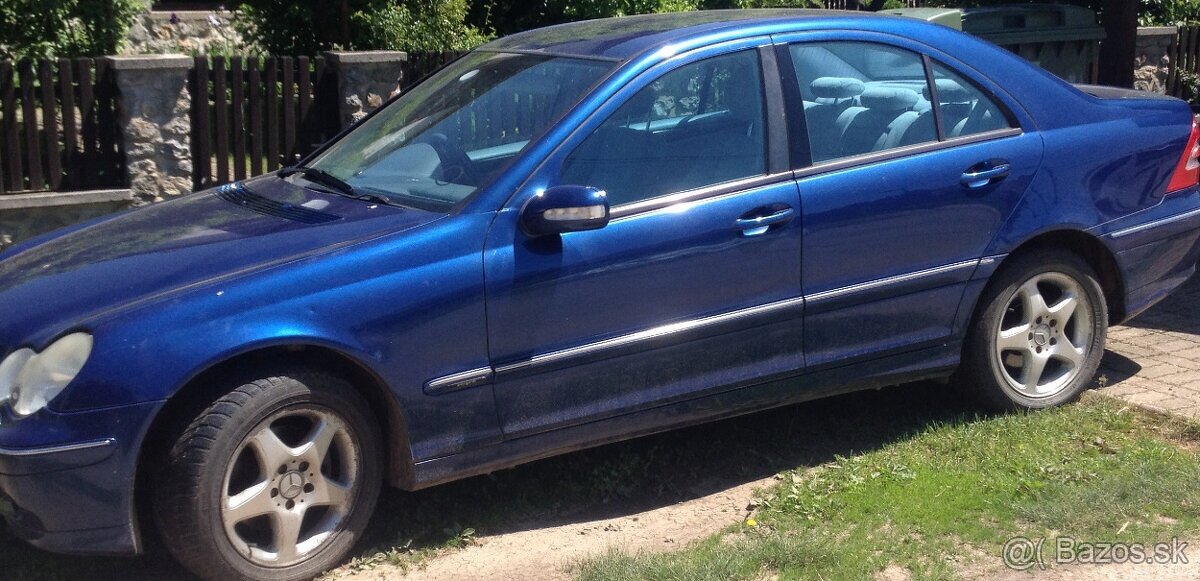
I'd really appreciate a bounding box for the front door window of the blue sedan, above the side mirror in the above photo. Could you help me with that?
[559,50,767,205]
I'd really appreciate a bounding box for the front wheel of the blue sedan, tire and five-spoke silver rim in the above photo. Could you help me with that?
[151,372,383,581]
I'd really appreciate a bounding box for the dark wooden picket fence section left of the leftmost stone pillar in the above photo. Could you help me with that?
[0,59,125,193]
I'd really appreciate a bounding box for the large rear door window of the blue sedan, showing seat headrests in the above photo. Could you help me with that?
[790,42,937,163]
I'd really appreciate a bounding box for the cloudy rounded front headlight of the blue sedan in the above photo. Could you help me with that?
[0,333,92,417]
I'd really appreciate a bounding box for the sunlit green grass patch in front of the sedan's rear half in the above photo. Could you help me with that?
[574,397,1200,581]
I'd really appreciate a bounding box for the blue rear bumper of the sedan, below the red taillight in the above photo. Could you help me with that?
[1103,188,1200,319]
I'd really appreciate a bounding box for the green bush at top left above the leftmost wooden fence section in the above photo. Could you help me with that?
[0,0,145,59]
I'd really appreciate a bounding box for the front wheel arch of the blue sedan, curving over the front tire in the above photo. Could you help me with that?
[132,342,414,554]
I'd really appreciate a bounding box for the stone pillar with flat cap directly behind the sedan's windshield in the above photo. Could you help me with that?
[324,50,408,127]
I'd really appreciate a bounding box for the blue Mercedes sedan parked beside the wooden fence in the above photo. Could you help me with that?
[0,11,1200,580]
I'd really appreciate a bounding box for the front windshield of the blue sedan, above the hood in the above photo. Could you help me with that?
[308,52,612,210]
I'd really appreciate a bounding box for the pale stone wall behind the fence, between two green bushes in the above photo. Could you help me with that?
[121,10,244,54]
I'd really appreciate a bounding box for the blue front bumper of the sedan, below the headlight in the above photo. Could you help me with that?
[0,403,158,555]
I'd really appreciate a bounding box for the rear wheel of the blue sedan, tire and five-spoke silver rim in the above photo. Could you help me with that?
[955,248,1109,411]
